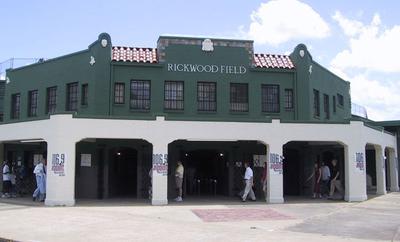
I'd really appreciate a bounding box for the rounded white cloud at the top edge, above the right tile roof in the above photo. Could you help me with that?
[245,0,330,45]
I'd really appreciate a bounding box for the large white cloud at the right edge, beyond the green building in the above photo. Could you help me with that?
[330,12,400,120]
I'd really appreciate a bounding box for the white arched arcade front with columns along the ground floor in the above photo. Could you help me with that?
[0,115,397,205]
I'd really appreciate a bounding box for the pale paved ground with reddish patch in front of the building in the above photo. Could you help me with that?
[0,193,400,242]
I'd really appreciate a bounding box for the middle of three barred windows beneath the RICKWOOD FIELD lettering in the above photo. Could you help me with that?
[197,82,217,111]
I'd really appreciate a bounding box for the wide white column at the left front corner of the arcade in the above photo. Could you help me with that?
[45,138,76,206]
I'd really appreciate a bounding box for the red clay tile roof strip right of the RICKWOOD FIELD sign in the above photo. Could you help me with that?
[254,54,295,69]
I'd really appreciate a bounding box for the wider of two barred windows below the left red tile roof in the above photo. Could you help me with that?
[130,81,150,110]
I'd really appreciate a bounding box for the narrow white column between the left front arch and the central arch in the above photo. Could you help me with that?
[151,141,168,205]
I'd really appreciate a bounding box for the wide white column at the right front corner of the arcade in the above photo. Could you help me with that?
[342,143,367,202]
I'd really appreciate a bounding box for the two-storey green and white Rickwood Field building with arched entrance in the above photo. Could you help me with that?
[0,33,399,205]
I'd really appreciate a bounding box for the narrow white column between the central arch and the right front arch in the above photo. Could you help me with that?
[265,142,284,203]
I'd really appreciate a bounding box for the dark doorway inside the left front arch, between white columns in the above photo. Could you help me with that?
[109,148,137,197]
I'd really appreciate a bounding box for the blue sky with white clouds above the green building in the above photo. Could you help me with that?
[0,0,400,120]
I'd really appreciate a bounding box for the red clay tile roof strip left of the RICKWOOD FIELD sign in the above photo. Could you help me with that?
[111,46,157,63]
